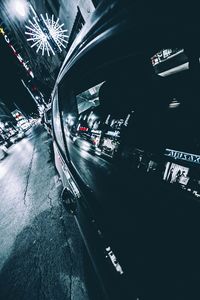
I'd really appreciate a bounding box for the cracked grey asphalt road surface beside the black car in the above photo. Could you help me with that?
[0,125,91,300]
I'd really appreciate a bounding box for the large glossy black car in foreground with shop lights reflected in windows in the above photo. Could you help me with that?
[52,1,200,300]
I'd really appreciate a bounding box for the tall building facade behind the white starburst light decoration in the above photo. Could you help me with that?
[0,0,97,102]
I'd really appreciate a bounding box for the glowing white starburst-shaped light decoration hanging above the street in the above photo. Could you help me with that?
[25,14,68,56]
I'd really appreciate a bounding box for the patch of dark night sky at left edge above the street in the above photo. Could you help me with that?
[0,34,36,113]
